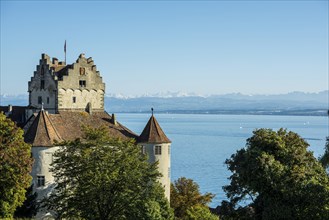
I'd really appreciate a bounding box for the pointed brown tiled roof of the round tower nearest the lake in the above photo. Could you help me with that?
[138,114,171,144]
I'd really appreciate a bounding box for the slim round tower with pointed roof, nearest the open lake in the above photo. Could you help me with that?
[138,112,171,201]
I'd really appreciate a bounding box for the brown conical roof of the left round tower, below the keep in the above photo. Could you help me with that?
[24,110,62,147]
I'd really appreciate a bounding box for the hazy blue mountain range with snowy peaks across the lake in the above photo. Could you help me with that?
[0,90,329,116]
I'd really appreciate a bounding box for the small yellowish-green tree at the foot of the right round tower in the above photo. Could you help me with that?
[170,177,215,219]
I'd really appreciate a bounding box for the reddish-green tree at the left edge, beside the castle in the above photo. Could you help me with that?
[0,113,32,218]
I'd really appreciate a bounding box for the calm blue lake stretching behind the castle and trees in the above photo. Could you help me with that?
[117,113,329,207]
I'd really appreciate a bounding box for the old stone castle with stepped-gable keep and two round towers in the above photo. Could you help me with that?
[0,54,171,217]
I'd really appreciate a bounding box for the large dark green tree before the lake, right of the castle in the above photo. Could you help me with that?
[222,129,329,219]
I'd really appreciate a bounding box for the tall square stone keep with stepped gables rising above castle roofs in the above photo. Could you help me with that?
[28,54,105,113]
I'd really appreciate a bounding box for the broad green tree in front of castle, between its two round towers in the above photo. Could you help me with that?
[46,127,173,219]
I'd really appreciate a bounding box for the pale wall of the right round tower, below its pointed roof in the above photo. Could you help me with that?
[141,143,171,201]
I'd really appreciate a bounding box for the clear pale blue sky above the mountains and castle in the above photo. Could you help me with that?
[1,1,328,95]
